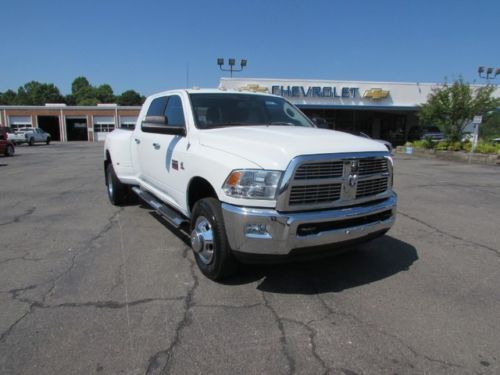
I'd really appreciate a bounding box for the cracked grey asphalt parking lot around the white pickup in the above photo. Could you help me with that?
[0,143,500,375]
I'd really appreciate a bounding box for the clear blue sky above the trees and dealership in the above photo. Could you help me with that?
[0,0,500,95]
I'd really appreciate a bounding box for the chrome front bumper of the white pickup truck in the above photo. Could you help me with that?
[222,193,397,255]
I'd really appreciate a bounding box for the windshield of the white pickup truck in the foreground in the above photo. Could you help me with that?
[189,93,314,129]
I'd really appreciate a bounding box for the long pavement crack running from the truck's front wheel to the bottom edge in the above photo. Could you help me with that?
[146,247,199,375]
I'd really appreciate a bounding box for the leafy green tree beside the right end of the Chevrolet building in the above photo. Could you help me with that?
[418,79,500,142]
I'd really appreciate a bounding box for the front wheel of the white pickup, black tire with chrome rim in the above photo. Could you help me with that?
[191,198,237,280]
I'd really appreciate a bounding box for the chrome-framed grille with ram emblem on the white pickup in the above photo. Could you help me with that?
[278,153,392,210]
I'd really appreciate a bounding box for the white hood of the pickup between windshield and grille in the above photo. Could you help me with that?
[200,126,387,170]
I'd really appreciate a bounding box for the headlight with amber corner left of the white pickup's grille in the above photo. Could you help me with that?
[222,169,281,200]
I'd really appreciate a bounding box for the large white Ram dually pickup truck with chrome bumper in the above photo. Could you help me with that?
[104,89,397,280]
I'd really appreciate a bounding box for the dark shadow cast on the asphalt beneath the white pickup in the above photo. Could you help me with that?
[148,206,418,294]
